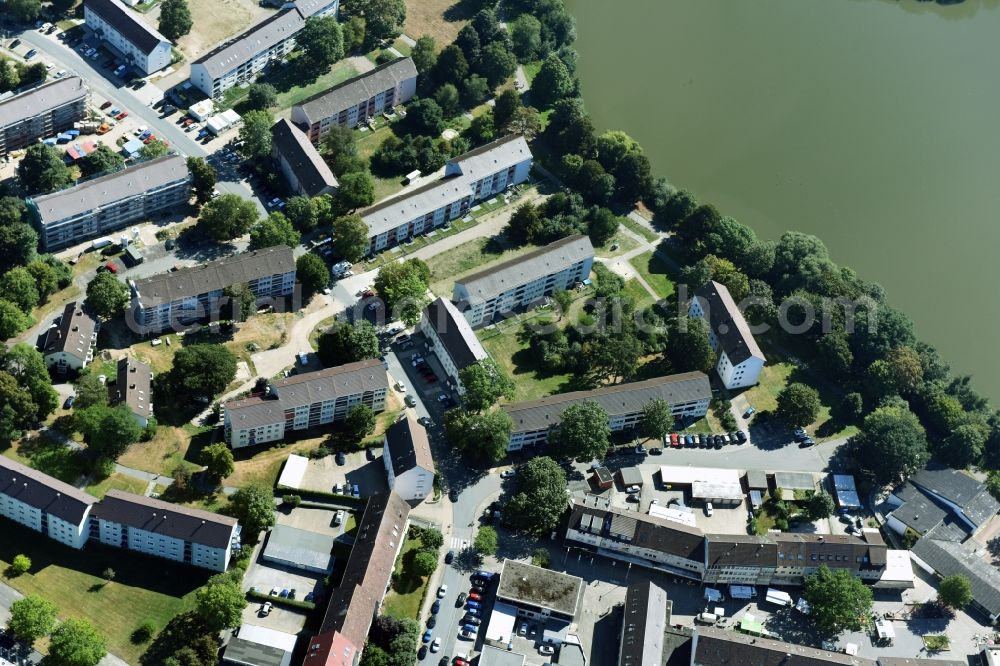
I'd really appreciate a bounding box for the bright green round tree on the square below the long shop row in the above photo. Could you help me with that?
[804,564,872,633]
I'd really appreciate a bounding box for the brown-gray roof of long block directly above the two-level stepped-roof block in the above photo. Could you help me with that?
[133,245,295,308]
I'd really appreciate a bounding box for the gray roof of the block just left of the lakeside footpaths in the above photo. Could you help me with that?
[455,234,594,303]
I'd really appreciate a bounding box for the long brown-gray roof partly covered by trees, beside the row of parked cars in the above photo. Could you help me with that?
[503,372,712,433]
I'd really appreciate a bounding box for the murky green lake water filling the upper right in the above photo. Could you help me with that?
[567,0,1000,401]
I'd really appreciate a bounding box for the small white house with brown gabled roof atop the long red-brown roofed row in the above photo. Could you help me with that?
[382,409,434,502]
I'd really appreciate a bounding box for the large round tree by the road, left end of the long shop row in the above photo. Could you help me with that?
[503,456,566,536]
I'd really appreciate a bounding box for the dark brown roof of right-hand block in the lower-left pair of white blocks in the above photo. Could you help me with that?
[94,490,237,548]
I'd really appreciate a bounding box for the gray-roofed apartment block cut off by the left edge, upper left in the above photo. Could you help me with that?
[0,76,90,157]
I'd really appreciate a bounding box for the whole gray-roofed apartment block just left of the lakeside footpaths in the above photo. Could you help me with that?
[452,234,594,326]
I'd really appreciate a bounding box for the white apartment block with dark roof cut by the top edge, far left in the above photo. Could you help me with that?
[83,0,171,74]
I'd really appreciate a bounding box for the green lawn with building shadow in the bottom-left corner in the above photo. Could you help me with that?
[0,520,210,664]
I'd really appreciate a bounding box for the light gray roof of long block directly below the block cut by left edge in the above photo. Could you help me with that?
[29,155,190,226]
